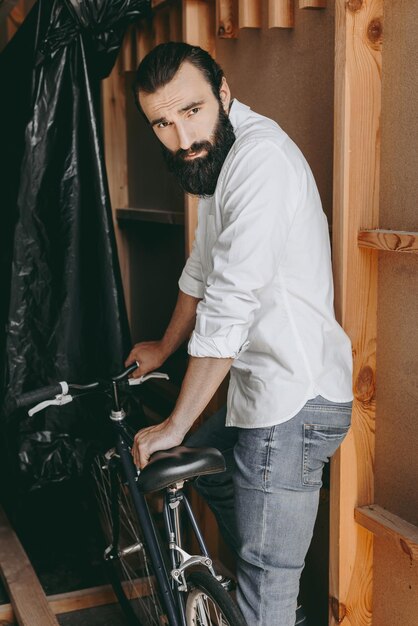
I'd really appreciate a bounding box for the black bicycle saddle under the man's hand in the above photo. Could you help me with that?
[138,446,225,493]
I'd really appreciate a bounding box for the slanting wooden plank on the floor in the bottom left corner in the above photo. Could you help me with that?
[0,508,59,626]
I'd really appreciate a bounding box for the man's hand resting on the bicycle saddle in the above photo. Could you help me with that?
[132,417,187,469]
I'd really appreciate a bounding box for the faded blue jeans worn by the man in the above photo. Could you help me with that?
[186,396,351,626]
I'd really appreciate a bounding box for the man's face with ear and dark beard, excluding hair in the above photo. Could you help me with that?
[139,62,235,195]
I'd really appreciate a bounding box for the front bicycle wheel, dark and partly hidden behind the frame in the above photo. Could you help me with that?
[92,453,168,626]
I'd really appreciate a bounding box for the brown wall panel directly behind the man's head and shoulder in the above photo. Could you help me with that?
[216,2,334,219]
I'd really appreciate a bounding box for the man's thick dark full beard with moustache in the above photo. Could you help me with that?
[162,106,235,196]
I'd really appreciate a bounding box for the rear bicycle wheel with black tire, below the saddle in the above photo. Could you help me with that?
[186,570,246,626]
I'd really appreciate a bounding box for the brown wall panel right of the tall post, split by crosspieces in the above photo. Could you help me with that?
[373,0,418,626]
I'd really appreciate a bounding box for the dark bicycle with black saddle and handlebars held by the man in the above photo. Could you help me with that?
[16,364,245,626]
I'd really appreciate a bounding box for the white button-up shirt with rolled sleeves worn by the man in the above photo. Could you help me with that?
[179,100,352,428]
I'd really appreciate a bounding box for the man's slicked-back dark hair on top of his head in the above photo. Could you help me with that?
[133,41,224,103]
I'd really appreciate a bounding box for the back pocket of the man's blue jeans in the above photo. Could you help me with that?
[302,424,350,487]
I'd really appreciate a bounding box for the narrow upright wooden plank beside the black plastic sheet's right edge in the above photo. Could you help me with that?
[102,57,131,321]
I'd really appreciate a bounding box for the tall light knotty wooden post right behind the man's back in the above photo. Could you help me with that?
[329,0,383,626]
